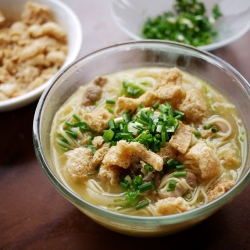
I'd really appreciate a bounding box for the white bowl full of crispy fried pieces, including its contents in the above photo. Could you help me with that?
[0,0,82,111]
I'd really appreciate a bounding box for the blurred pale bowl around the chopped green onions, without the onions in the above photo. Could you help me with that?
[110,0,250,51]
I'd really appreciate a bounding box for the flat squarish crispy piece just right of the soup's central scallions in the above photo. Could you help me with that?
[169,121,193,154]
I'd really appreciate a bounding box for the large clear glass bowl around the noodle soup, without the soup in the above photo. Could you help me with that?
[33,40,250,237]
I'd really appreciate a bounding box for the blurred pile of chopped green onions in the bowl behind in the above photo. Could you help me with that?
[142,0,222,47]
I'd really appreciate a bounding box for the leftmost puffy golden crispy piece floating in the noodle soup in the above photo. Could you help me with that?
[66,147,95,181]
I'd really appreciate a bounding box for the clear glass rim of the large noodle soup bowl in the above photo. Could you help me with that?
[33,40,250,225]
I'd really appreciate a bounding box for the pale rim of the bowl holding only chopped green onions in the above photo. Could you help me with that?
[109,0,250,51]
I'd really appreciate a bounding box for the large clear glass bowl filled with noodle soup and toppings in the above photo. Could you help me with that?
[33,40,250,237]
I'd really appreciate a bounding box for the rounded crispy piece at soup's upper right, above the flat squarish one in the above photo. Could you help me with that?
[177,89,207,122]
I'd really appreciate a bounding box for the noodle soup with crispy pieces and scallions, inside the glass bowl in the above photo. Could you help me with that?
[51,68,244,216]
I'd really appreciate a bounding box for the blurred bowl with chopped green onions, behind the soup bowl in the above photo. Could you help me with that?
[110,0,250,51]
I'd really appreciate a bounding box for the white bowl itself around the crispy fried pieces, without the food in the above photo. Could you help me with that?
[0,0,82,112]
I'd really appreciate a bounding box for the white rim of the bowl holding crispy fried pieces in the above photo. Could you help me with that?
[0,0,83,112]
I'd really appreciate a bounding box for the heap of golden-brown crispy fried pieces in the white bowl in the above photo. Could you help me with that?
[0,2,68,101]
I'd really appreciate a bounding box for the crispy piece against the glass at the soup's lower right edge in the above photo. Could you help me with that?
[207,179,235,202]
